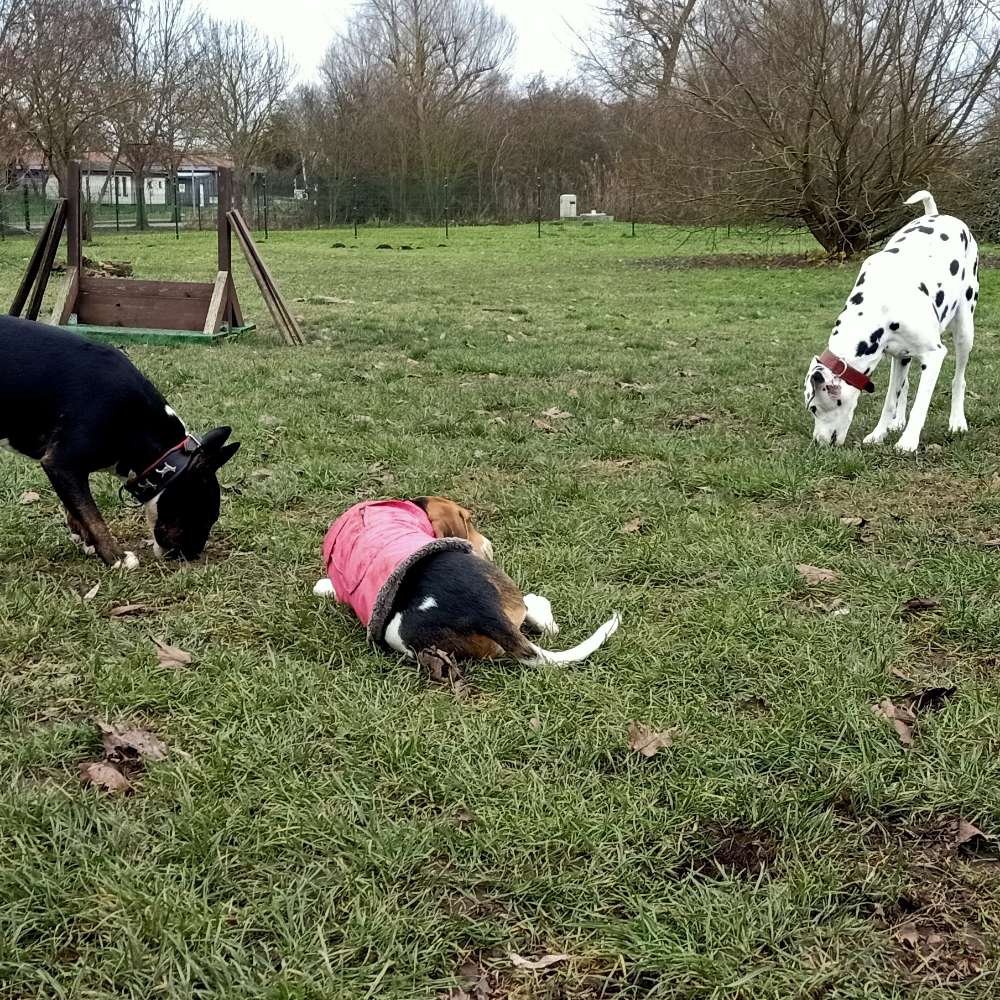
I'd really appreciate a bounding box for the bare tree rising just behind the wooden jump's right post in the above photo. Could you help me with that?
[203,20,294,204]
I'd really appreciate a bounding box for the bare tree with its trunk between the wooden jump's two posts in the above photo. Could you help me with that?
[109,0,204,229]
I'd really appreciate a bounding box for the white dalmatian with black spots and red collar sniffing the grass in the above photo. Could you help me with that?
[805,191,979,452]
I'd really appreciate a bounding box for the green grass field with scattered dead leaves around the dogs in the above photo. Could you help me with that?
[0,226,1000,1000]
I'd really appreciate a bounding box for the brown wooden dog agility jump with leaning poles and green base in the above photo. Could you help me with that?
[10,163,304,345]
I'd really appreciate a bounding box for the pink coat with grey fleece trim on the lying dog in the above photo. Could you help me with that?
[323,500,472,644]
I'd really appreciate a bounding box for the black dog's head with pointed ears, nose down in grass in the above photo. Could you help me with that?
[146,427,240,559]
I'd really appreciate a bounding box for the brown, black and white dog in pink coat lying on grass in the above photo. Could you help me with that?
[313,496,620,665]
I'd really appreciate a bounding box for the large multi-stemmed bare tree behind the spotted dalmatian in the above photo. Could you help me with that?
[687,0,1000,253]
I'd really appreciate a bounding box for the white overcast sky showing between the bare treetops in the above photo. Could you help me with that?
[203,0,597,81]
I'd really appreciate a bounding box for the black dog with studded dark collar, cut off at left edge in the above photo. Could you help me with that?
[0,316,239,569]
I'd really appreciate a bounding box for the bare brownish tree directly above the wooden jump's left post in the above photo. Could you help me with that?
[11,0,132,188]
